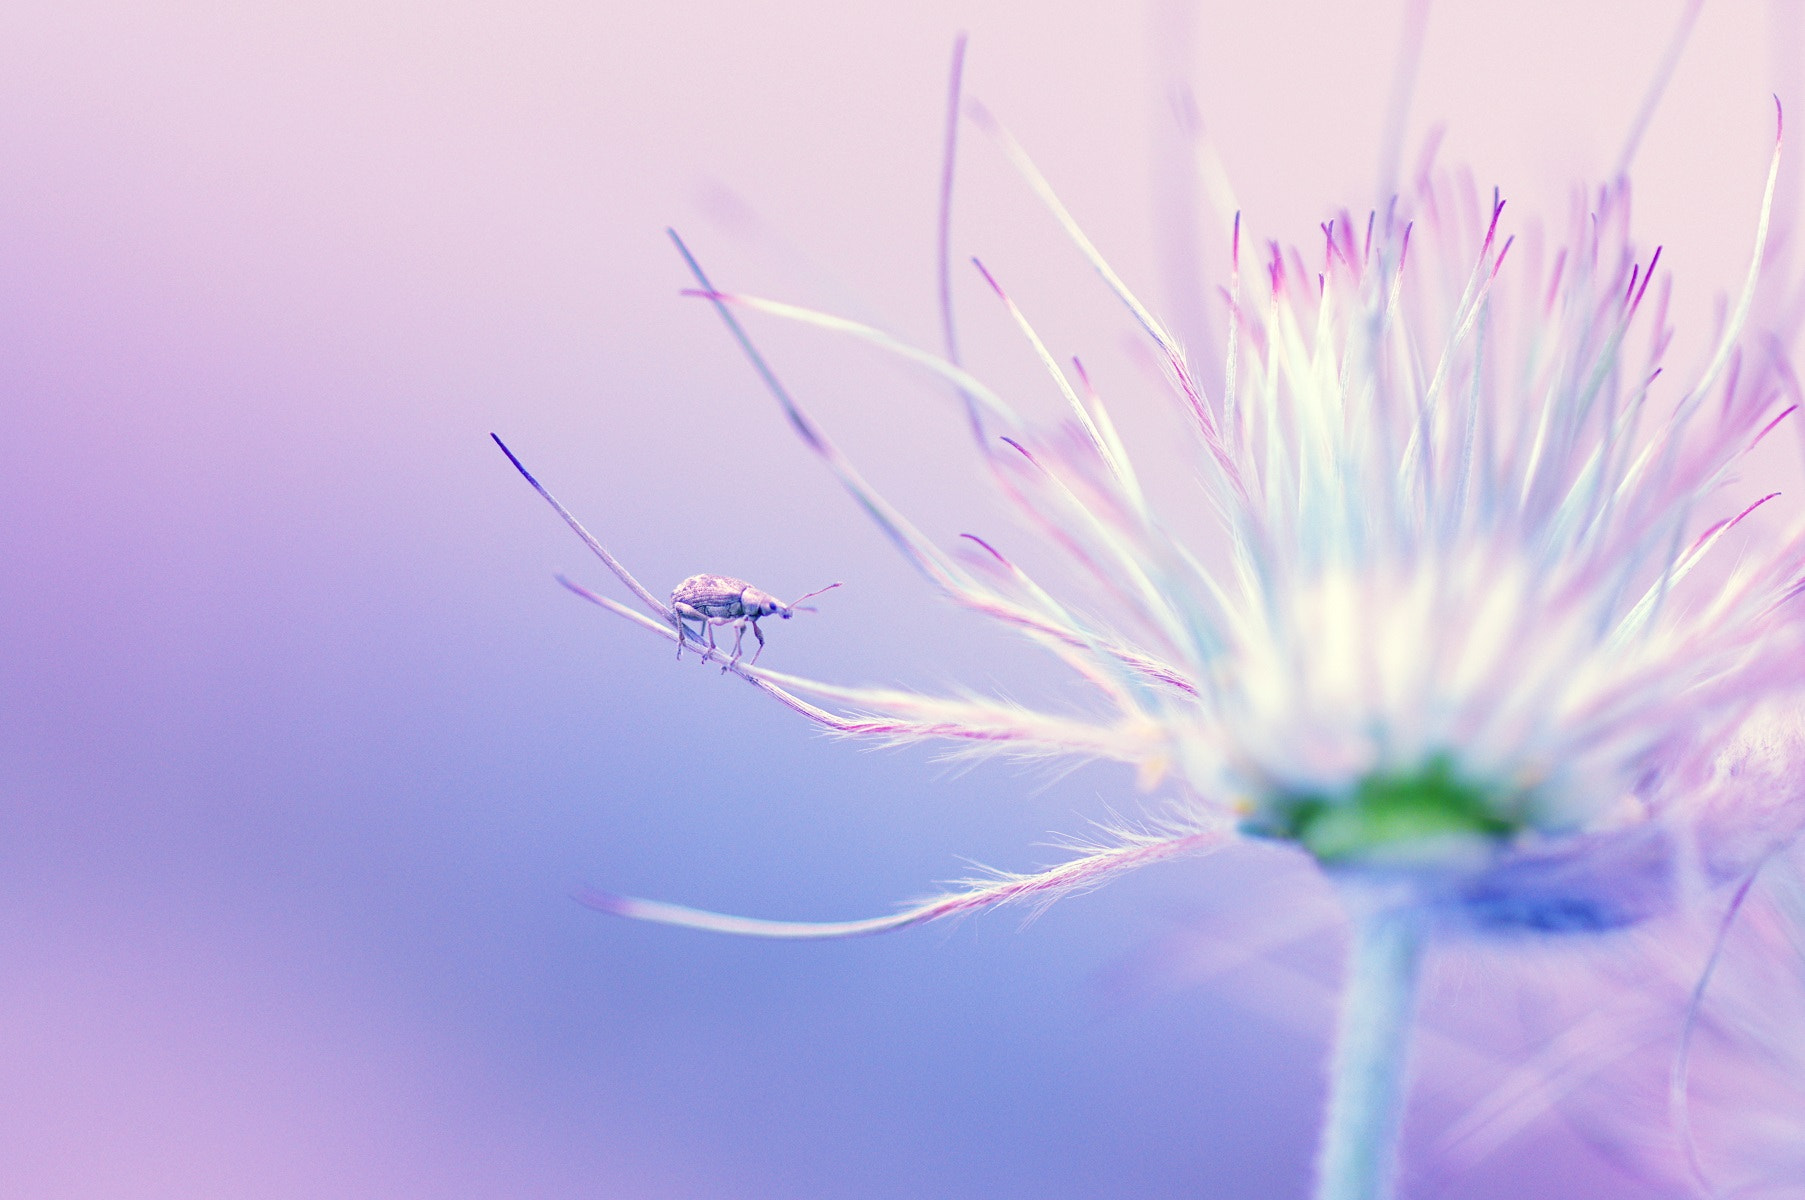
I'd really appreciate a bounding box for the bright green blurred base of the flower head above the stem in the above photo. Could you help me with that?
[1244,754,1523,866]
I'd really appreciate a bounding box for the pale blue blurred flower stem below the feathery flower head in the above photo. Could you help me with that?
[1316,908,1422,1200]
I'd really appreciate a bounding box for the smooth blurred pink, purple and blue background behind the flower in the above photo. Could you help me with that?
[0,0,1805,1198]
